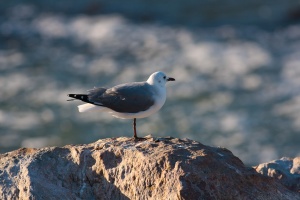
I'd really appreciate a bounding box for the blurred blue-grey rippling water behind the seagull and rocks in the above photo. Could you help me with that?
[0,0,300,165]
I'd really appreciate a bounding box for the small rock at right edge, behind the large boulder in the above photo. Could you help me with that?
[255,157,300,193]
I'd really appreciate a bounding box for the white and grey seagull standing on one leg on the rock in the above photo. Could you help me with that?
[68,71,175,139]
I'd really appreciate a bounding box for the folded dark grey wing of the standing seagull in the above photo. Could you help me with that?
[88,82,155,113]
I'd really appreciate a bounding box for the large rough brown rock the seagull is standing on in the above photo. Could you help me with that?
[0,136,300,200]
